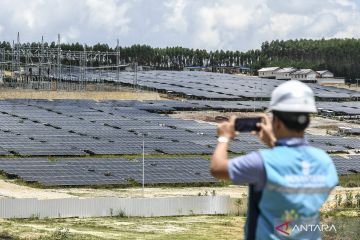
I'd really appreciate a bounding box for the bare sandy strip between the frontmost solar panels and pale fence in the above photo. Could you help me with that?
[0,176,360,210]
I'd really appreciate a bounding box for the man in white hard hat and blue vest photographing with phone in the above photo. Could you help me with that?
[211,80,338,240]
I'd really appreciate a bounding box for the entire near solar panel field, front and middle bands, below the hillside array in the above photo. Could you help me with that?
[0,87,360,186]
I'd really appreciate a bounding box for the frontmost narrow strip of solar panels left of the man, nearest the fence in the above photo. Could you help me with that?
[0,158,217,186]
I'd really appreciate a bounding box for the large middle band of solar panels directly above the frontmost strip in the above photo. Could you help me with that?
[0,100,360,156]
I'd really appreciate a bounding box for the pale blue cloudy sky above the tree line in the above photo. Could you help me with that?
[0,0,360,51]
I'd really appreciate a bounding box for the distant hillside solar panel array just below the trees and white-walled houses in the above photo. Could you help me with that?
[107,71,360,100]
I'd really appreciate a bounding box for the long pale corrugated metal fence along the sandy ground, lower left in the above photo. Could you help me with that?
[0,196,230,218]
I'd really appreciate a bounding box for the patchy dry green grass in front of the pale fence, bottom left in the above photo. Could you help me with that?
[0,216,245,240]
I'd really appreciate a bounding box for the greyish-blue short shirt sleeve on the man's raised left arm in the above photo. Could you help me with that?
[228,152,266,191]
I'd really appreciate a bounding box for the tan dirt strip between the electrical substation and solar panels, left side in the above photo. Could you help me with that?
[0,89,160,101]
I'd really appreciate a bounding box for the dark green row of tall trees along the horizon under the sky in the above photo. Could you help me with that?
[0,39,360,81]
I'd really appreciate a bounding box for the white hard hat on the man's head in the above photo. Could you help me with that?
[268,80,317,113]
